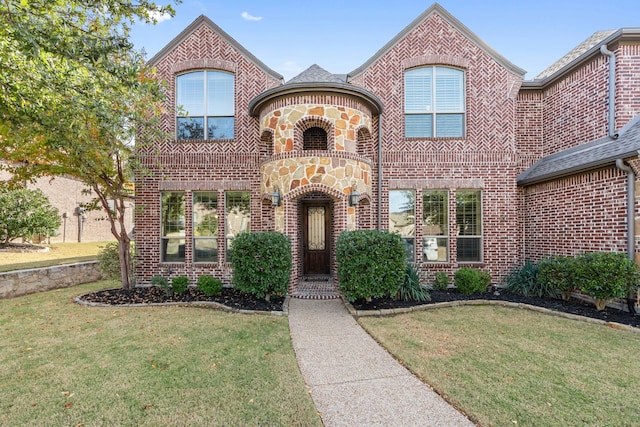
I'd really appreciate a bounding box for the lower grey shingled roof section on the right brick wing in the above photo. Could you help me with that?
[517,115,640,186]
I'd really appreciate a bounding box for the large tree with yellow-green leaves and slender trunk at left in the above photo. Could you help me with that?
[0,0,173,289]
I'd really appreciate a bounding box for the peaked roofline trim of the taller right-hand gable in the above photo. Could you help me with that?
[347,3,527,79]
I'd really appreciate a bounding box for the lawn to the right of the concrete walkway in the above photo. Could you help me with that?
[359,306,640,426]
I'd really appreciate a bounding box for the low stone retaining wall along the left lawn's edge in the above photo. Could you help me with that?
[0,261,102,298]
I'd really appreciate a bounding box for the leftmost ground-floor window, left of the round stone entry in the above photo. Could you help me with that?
[160,191,185,262]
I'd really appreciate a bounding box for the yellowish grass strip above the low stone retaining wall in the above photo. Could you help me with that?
[0,242,108,272]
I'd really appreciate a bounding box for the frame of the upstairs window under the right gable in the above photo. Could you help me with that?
[403,65,467,138]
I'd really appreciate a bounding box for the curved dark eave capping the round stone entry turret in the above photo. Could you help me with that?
[249,82,382,117]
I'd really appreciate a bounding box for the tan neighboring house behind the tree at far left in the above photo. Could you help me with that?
[0,165,134,243]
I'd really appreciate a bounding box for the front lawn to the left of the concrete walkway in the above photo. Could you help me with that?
[0,282,321,426]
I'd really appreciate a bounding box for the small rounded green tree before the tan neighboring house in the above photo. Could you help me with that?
[0,187,60,248]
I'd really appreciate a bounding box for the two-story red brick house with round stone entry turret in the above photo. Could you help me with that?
[136,4,640,300]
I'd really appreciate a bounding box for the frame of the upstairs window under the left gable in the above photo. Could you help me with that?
[175,69,235,141]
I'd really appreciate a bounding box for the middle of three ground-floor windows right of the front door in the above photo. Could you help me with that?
[422,190,449,262]
